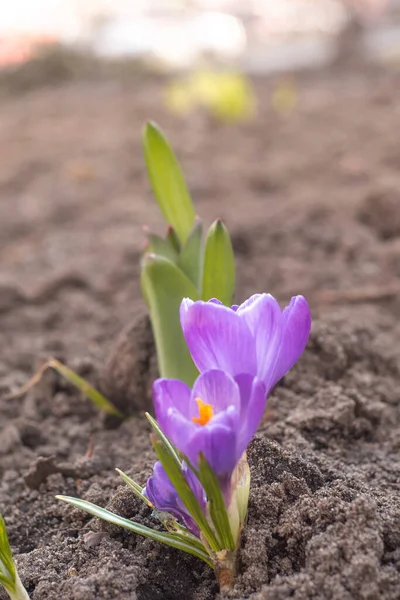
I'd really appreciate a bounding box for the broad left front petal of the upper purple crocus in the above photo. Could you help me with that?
[180,299,257,376]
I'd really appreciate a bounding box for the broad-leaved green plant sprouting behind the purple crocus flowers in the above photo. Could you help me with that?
[141,123,235,385]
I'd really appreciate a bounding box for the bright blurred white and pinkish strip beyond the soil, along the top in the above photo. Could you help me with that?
[0,0,400,73]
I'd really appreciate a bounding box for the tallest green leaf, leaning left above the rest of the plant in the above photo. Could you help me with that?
[143,123,195,243]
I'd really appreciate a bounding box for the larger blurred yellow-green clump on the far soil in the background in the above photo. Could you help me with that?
[165,70,256,123]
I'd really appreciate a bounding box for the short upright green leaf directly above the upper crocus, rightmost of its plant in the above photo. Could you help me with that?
[202,219,235,306]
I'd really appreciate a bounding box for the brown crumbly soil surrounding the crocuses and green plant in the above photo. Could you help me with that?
[0,57,400,600]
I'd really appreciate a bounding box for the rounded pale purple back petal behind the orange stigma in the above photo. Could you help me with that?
[190,369,240,418]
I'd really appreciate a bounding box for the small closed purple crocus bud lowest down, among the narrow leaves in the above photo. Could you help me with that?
[143,461,206,536]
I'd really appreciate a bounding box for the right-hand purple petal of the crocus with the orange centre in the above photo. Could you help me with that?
[236,375,267,457]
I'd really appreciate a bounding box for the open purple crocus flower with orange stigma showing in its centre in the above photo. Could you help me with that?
[153,369,266,496]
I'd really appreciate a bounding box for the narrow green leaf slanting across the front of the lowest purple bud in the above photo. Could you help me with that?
[152,439,222,552]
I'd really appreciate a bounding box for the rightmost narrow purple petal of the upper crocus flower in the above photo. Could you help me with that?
[272,296,311,385]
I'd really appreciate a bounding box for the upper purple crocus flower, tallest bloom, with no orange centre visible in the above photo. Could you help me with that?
[180,294,311,393]
